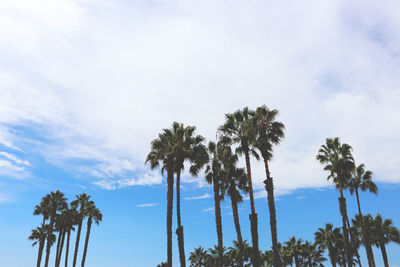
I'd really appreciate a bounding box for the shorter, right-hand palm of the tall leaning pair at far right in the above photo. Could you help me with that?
[349,164,378,267]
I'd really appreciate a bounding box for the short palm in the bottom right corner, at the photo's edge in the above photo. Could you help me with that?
[372,214,400,267]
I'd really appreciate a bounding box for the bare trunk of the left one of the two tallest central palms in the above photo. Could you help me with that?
[244,149,260,267]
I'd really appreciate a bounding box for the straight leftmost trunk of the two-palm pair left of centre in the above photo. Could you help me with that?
[167,170,174,267]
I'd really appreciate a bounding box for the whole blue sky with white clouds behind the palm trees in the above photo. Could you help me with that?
[0,0,400,267]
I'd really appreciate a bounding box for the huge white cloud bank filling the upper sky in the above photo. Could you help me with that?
[0,0,400,195]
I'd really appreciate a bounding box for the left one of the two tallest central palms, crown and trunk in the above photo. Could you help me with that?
[218,107,260,267]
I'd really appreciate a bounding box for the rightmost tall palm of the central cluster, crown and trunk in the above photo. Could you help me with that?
[254,105,285,266]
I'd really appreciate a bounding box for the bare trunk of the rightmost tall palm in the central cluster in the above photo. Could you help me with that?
[264,159,282,267]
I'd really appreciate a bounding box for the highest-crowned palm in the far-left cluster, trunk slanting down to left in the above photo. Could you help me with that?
[44,190,67,267]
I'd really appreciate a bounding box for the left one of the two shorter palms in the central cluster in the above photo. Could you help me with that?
[205,142,226,266]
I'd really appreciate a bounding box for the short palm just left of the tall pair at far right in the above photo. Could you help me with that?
[314,223,340,267]
